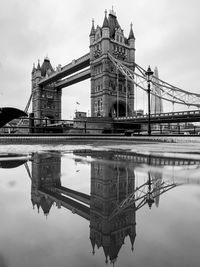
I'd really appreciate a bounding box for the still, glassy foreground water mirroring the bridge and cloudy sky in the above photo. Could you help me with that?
[0,144,200,267]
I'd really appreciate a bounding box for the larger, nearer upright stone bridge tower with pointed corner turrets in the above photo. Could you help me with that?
[90,10,135,117]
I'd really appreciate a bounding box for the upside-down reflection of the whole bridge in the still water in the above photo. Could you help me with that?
[31,150,200,263]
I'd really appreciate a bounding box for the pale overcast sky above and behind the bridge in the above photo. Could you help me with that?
[0,0,200,119]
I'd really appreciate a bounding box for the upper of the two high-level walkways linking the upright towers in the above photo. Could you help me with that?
[38,53,90,86]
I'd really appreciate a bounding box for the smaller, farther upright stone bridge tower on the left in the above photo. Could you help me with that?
[32,57,61,125]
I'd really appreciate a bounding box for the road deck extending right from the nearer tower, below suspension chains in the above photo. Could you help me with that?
[114,110,200,124]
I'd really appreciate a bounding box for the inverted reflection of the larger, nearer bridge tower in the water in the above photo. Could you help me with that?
[90,155,136,263]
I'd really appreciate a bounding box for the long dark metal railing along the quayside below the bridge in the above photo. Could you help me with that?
[0,117,200,136]
